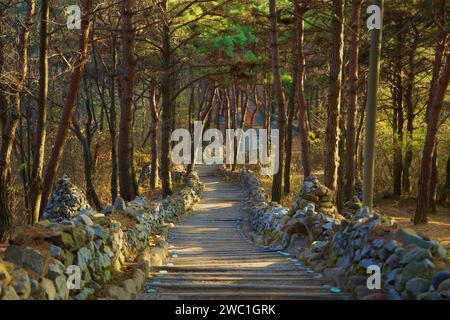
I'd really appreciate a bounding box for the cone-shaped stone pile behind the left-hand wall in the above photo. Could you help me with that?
[43,175,92,222]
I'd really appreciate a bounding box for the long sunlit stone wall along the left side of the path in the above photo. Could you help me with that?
[0,173,203,300]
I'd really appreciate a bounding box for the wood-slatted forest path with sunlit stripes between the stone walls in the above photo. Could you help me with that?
[137,168,343,300]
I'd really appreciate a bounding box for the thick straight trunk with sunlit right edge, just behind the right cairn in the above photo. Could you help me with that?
[324,0,344,190]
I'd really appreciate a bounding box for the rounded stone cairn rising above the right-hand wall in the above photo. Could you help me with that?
[289,176,337,216]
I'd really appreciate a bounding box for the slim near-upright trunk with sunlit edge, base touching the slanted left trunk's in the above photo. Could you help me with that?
[31,0,50,223]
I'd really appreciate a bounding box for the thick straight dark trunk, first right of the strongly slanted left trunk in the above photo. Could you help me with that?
[118,0,136,201]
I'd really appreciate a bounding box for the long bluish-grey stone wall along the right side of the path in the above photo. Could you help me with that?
[219,168,450,300]
